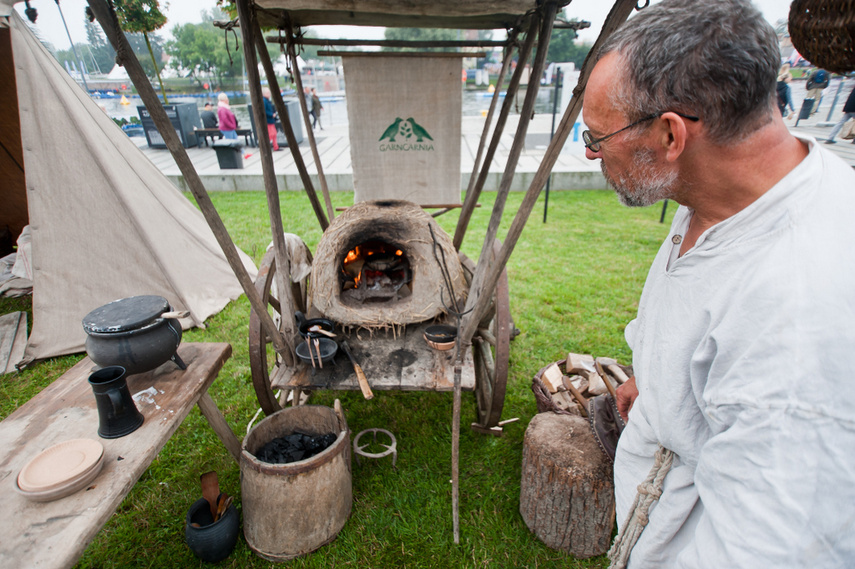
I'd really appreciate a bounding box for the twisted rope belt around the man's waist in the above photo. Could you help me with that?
[608,445,674,569]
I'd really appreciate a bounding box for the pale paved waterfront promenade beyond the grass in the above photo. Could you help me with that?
[137,79,855,191]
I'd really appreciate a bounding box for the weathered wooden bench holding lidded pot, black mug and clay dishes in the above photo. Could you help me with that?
[0,343,240,567]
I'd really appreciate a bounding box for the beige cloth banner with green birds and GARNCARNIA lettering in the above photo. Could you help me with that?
[342,54,463,205]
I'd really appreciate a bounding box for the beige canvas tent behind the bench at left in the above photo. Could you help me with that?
[0,6,256,361]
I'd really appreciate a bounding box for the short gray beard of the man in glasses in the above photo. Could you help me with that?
[600,148,677,207]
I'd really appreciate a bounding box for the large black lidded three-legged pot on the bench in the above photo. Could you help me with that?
[83,295,187,375]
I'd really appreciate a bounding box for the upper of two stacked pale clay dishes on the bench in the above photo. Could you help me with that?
[18,439,104,492]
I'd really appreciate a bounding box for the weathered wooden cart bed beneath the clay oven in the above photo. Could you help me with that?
[271,322,475,391]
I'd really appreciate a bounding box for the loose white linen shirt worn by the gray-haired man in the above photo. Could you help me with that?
[615,135,855,569]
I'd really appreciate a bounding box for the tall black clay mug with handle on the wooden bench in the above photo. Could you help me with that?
[89,366,145,439]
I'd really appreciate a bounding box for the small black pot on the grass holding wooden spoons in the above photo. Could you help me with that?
[184,498,240,563]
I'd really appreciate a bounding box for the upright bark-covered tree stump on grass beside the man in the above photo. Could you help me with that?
[520,413,615,559]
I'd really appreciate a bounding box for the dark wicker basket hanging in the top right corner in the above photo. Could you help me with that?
[789,0,855,73]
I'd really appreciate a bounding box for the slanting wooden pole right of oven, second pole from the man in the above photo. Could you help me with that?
[461,2,558,345]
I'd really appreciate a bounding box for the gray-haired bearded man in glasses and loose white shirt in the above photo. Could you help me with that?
[583,0,855,569]
